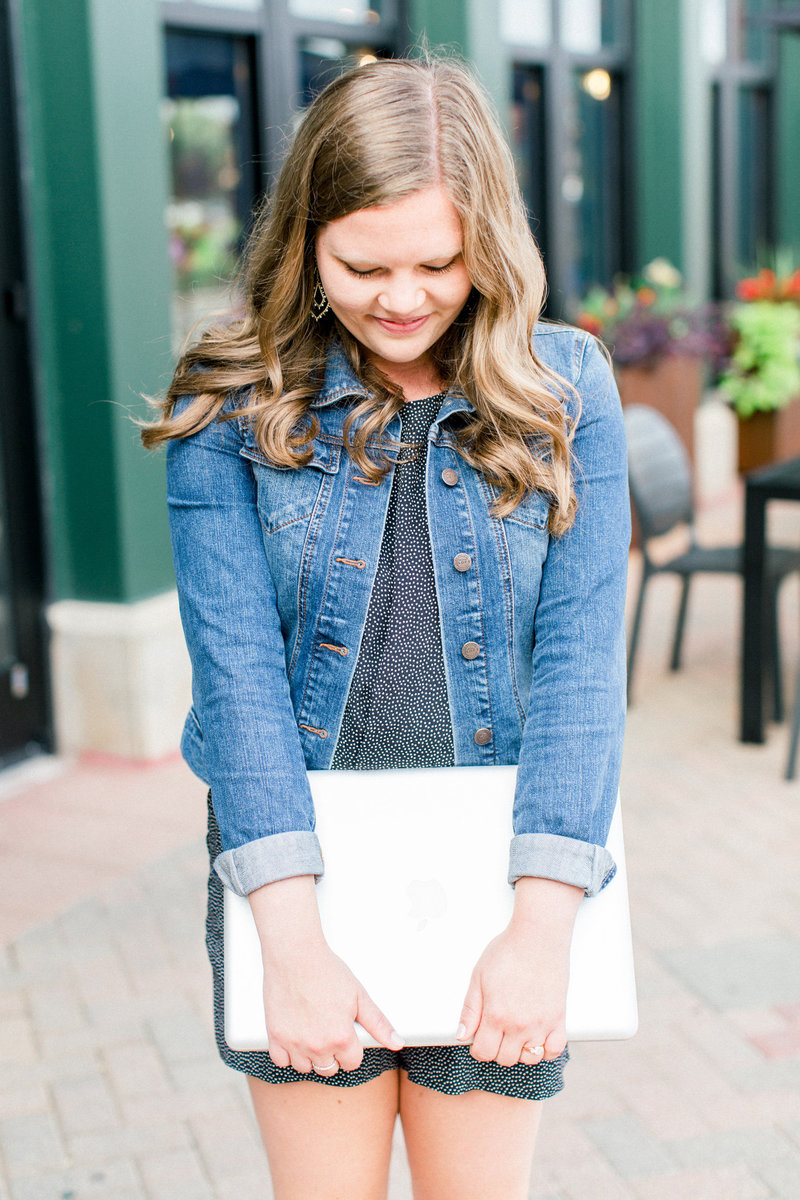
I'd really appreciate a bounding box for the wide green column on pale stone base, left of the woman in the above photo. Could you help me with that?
[20,0,173,601]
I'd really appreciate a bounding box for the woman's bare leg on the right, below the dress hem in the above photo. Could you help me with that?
[399,1070,542,1200]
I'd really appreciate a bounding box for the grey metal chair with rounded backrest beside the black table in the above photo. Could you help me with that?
[624,404,800,700]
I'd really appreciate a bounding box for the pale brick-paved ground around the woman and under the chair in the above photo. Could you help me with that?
[0,405,800,1200]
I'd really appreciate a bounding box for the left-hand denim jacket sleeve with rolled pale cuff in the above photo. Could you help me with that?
[167,401,323,895]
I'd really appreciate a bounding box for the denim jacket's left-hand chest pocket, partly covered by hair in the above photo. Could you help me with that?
[239,440,342,534]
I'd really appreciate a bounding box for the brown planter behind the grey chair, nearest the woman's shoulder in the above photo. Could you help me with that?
[614,355,705,463]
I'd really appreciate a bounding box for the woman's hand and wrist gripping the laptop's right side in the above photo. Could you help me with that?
[457,876,583,1067]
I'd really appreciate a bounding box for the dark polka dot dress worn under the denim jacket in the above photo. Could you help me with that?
[206,394,569,1100]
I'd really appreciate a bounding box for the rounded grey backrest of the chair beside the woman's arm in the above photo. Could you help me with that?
[622,404,693,540]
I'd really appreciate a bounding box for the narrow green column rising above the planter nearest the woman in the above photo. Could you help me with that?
[632,0,684,269]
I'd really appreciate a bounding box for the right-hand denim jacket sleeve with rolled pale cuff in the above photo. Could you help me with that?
[509,338,631,895]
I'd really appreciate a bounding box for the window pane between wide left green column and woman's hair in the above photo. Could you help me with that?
[163,31,259,352]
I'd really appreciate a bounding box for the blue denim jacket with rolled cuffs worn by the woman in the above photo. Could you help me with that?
[167,325,630,895]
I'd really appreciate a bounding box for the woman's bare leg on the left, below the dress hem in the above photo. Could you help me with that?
[247,1070,399,1200]
